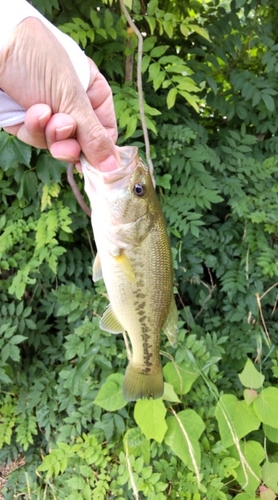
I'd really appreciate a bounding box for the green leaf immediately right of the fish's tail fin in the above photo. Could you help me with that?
[163,362,199,394]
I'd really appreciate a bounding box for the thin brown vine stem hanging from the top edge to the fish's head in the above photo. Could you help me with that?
[119,0,153,176]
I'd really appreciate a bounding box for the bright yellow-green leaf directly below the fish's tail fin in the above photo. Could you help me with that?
[134,399,167,443]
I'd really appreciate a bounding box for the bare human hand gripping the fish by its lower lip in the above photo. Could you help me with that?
[0,18,119,171]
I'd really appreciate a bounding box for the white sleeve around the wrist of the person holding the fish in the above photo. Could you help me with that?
[0,0,90,127]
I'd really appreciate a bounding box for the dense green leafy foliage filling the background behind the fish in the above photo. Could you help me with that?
[0,0,278,500]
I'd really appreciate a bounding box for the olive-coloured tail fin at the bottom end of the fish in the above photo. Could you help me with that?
[123,361,164,401]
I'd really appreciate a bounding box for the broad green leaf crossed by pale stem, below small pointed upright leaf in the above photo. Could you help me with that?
[215,394,261,448]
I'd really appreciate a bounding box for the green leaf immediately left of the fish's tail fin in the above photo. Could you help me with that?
[94,373,127,411]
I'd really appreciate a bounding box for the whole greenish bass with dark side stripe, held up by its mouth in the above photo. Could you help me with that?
[81,146,178,401]
